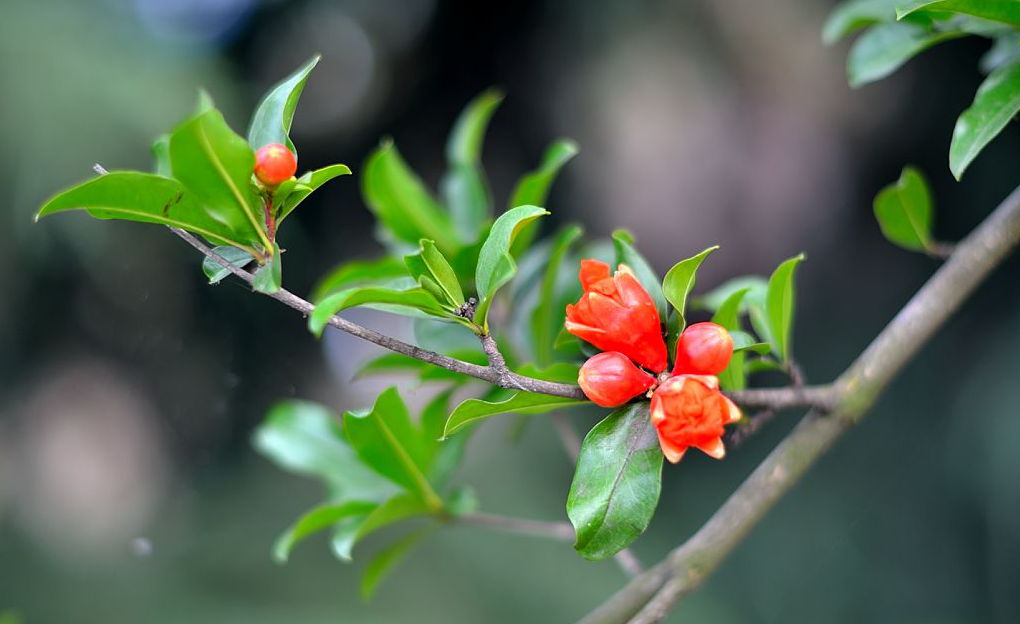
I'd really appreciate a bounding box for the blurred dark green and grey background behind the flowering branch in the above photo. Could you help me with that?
[0,0,1020,624]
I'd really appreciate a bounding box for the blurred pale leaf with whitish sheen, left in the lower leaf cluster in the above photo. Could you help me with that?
[252,400,396,503]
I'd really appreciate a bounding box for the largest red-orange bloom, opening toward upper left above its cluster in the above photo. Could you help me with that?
[565,259,666,372]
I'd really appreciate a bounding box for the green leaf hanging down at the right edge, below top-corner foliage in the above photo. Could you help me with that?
[950,62,1020,179]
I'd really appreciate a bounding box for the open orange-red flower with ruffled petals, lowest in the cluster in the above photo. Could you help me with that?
[652,375,741,464]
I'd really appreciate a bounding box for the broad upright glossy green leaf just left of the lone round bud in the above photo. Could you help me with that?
[170,109,272,250]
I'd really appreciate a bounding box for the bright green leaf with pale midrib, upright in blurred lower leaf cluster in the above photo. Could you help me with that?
[344,387,443,511]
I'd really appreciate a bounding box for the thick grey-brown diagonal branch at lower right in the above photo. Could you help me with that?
[581,182,1020,624]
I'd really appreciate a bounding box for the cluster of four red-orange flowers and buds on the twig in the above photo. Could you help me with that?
[565,259,741,463]
